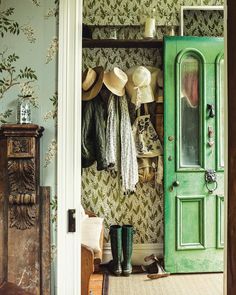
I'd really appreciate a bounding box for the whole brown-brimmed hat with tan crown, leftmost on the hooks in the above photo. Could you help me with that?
[82,67,104,101]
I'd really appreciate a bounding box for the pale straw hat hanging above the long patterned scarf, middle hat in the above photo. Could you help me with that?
[103,67,128,96]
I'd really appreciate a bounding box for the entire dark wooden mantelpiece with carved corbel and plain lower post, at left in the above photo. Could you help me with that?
[0,124,50,294]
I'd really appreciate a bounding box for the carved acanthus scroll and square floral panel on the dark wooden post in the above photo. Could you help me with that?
[8,145,36,230]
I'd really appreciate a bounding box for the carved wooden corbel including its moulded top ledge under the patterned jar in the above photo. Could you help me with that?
[2,124,43,230]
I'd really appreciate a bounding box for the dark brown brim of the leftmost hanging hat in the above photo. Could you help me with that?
[82,67,104,101]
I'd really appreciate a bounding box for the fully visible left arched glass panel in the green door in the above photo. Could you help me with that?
[178,54,202,168]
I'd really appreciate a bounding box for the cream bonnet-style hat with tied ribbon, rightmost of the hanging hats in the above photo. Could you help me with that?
[126,66,156,108]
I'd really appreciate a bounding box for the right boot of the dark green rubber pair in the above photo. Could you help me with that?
[122,224,134,276]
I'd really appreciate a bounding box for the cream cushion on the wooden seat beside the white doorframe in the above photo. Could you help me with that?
[81,217,103,253]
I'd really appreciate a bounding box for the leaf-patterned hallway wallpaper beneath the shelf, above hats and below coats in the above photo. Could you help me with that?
[82,46,163,243]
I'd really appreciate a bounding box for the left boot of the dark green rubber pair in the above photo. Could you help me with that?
[109,225,122,276]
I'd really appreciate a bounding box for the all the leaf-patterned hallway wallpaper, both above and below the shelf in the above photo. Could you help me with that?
[82,0,223,243]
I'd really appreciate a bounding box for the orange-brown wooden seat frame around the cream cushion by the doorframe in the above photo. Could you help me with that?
[81,211,104,295]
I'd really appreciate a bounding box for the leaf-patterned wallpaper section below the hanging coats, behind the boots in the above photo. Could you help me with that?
[82,166,163,243]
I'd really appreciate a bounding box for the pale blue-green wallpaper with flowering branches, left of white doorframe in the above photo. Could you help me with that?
[0,0,59,293]
